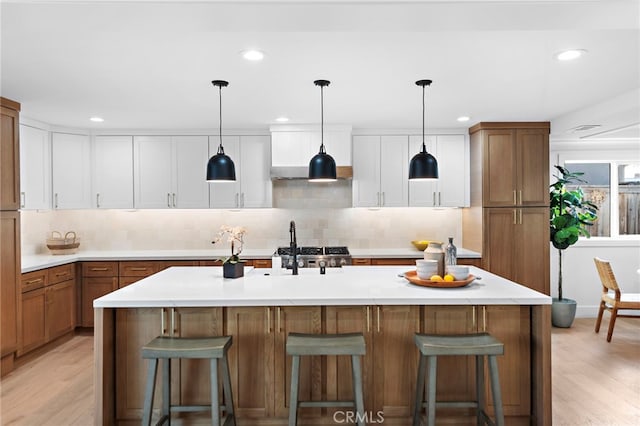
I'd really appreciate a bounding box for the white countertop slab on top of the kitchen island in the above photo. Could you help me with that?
[93,266,551,308]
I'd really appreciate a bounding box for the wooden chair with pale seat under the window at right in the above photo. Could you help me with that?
[593,257,640,342]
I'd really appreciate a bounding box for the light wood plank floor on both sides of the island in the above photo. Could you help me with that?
[0,315,640,426]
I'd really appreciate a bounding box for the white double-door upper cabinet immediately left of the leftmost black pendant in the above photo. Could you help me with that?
[133,136,209,209]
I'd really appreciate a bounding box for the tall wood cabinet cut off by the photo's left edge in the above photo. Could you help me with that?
[0,98,20,375]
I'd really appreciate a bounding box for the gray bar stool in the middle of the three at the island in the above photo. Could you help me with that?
[287,333,366,426]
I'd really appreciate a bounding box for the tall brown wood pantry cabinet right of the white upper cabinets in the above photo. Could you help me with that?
[463,122,550,294]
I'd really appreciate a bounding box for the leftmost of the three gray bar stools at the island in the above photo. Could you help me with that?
[142,336,235,426]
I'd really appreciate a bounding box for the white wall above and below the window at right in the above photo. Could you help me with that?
[549,89,640,317]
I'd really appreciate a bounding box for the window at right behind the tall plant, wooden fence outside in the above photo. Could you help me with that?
[565,160,640,237]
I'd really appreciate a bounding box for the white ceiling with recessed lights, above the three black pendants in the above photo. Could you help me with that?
[0,0,640,135]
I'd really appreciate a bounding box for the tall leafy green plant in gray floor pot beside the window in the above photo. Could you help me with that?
[549,165,598,328]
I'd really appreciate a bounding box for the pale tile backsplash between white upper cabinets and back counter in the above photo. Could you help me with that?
[21,206,462,255]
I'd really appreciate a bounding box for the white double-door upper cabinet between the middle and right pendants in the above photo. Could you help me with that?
[352,136,408,207]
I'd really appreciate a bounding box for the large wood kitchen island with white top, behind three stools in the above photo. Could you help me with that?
[94,266,551,425]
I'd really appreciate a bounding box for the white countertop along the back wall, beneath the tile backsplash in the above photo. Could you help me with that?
[21,248,481,273]
